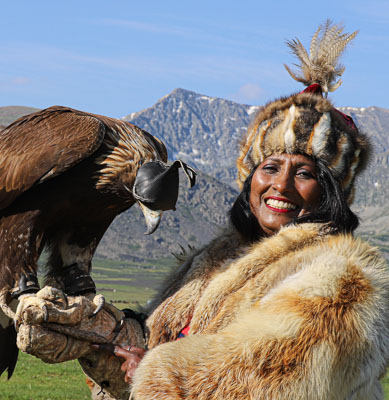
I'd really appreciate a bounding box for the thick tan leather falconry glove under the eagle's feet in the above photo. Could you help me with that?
[15,286,145,400]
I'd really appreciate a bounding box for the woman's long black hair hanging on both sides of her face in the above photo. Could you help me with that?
[229,159,359,242]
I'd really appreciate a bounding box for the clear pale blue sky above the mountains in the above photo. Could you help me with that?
[0,0,389,117]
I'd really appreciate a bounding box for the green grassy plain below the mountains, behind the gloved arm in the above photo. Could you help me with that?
[0,259,389,400]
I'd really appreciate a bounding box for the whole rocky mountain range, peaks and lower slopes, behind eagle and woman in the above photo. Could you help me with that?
[0,89,389,263]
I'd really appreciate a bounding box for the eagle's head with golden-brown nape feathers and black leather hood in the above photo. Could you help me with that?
[96,119,196,234]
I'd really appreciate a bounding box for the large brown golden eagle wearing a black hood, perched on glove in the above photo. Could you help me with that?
[0,106,195,377]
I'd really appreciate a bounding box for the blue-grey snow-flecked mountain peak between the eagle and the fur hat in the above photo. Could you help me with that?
[123,89,259,185]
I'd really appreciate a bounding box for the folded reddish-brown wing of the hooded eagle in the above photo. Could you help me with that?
[0,106,106,209]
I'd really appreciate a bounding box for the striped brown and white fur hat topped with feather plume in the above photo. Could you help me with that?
[237,21,369,202]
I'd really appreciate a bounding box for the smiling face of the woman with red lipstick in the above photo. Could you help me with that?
[250,154,321,236]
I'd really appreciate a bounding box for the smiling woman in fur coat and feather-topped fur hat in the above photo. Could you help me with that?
[112,23,389,400]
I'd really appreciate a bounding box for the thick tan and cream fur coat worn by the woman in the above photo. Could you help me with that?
[133,224,389,400]
